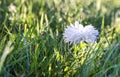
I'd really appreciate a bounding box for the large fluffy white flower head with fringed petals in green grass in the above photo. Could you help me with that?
[63,21,99,44]
